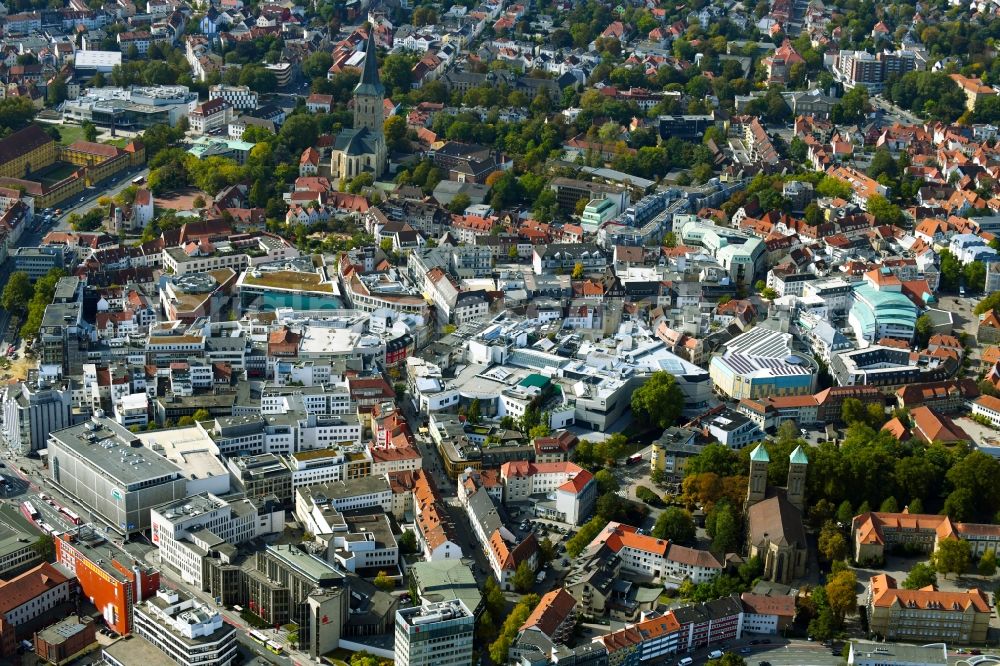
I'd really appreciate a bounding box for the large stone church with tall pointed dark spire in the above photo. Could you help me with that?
[330,29,388,185]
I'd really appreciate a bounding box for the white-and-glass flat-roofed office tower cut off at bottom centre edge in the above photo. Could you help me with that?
[395,599,475,666]
